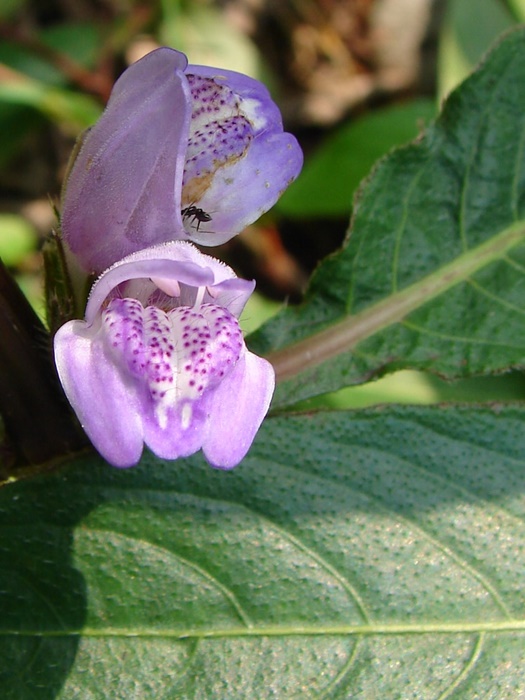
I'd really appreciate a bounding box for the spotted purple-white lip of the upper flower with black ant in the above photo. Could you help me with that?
[182,66,303,245]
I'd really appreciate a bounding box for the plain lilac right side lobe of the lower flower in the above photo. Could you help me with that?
[202,351,275,469]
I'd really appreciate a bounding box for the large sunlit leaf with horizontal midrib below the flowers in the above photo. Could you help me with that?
[0,407,525,700]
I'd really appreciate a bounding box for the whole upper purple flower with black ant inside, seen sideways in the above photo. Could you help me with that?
[61,48,302,273]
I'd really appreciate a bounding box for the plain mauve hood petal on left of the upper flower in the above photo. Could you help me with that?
[61,48,191,272]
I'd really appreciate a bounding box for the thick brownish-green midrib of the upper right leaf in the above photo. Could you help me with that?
[267,221,525,382]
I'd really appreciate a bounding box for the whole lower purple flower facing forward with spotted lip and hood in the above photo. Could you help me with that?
[54,241,274,469]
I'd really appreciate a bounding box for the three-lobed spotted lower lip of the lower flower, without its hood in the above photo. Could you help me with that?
[55,274,260,468]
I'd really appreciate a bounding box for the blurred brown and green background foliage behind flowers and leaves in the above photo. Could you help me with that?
[0,0,525,407]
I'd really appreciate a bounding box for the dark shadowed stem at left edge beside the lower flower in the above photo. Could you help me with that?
[0,261,86,478]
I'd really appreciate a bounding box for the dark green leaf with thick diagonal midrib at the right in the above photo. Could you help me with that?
[248,29,525,406]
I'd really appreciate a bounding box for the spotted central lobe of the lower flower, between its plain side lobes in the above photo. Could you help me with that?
[100,299,244,459]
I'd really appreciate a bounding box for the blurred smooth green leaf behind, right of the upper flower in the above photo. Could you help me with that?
[277,99,436,218]
